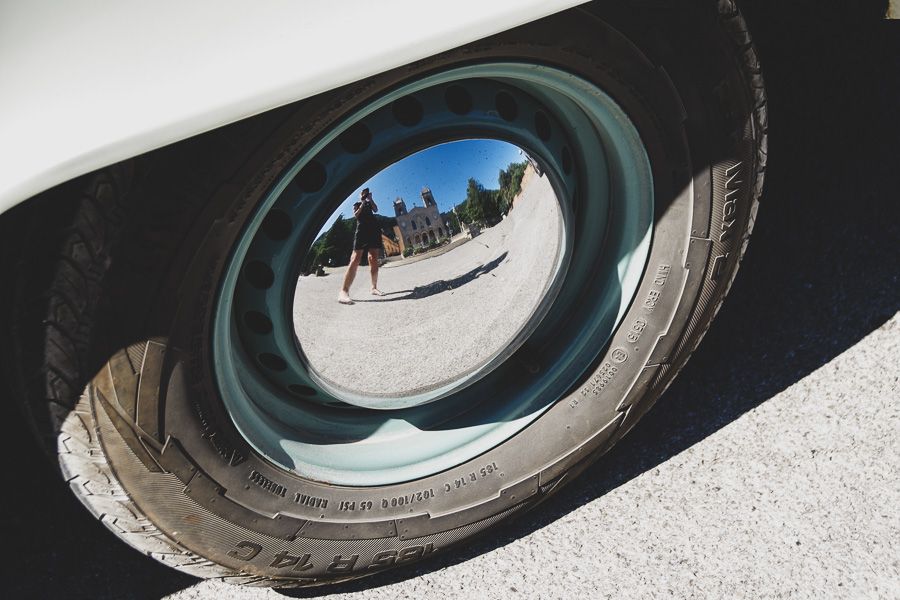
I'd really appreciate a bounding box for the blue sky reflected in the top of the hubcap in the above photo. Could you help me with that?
[322,139,525,231]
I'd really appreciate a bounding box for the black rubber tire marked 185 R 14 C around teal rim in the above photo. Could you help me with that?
[6,0,766,586]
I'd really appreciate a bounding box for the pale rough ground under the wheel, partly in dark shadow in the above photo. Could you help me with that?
[0,0,900,600]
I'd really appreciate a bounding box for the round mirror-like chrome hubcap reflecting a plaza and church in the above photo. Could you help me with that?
[294,140,563,409]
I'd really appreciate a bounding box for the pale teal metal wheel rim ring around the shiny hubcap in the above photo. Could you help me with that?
[212,63,653,486]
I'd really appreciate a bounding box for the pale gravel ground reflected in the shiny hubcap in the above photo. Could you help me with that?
[294,168,562,396]
